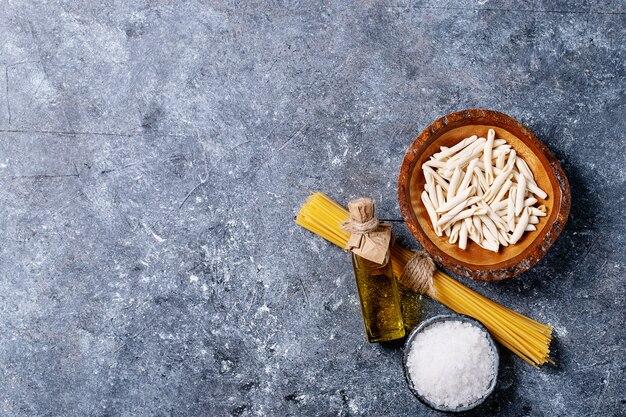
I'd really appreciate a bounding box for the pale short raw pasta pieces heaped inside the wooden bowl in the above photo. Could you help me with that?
[420,129,548,252]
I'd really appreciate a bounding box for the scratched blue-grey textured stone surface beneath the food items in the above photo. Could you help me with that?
[0,0,626,416]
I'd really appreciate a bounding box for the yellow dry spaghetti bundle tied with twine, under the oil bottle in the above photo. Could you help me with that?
[296,193,554,367]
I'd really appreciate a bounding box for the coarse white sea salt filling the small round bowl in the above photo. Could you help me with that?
[406,320,496,409]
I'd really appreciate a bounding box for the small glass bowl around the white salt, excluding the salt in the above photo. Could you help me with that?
[402,314,500,412]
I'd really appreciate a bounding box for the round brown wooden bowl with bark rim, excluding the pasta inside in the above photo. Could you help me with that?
[398,109,571,281]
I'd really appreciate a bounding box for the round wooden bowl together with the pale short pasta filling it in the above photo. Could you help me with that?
[398,109,571,281]
